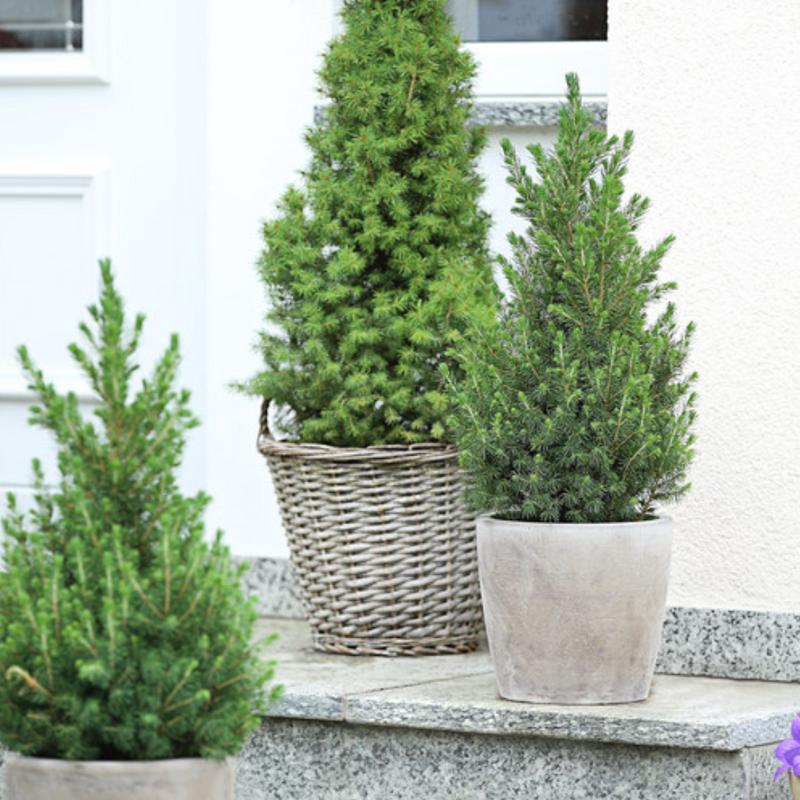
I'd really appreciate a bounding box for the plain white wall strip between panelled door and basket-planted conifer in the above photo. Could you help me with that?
[203,0,334,557]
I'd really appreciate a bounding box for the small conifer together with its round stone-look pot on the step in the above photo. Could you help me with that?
[451,75,695,703]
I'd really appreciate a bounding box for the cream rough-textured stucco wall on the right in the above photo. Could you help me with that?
[609,0,800,612]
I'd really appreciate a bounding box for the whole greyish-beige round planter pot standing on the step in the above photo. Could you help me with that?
[477,516,672,704]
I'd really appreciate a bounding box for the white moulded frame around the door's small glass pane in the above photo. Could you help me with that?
[0,0,110,85]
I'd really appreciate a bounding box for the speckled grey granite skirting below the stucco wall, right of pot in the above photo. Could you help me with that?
[656,608,800,681]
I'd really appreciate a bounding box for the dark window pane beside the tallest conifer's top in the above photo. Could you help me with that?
[448,0,608,42]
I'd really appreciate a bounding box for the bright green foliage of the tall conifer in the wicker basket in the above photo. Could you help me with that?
[239,0,497,447]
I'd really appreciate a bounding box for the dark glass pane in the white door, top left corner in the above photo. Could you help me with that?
[0,0,83,51]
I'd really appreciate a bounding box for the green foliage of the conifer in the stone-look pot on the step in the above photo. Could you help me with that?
[451,75,696,522]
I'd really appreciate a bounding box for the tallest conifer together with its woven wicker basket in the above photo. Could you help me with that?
[242,0,496,655]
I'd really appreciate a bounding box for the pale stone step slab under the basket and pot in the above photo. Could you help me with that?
[259,618,800,766]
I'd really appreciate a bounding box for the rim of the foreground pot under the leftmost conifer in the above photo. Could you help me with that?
[5,753,236,800]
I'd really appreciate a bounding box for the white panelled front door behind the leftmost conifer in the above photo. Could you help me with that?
[0,0,207,513]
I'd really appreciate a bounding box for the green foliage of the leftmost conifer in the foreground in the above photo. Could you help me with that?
[0,261,276,760]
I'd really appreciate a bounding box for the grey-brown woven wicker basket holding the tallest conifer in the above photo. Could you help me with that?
[258,402,483,656]
